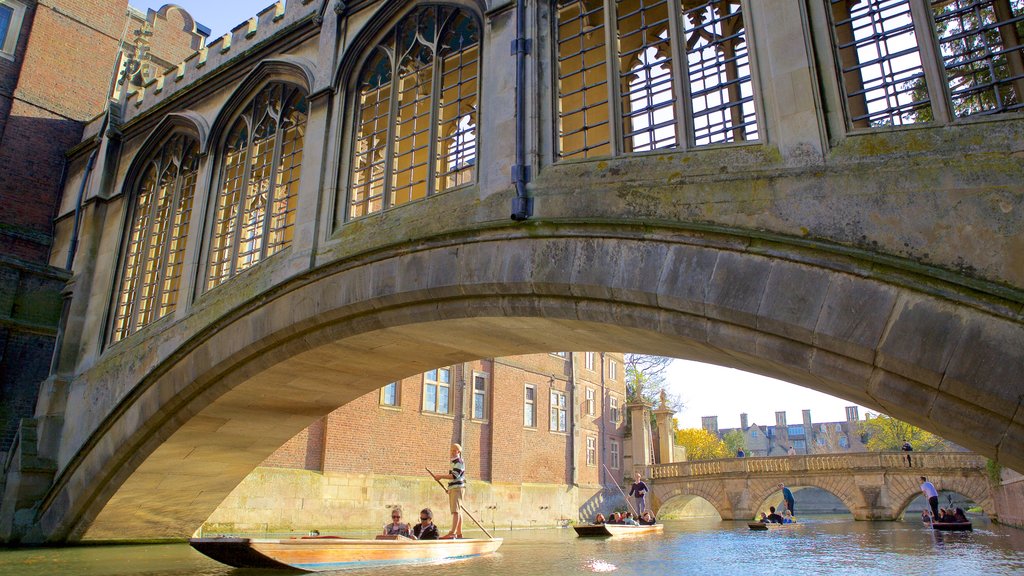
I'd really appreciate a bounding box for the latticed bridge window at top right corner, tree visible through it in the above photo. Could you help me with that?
[829,0,1024,128]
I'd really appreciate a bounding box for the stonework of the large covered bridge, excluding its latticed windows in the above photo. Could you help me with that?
[4,2,1024,541]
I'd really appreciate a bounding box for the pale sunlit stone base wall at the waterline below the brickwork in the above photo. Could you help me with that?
[201,467,625,535]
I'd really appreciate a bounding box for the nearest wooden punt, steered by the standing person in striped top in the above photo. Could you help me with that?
[188,536,502,572]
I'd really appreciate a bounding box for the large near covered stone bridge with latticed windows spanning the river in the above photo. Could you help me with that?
[0,0,1024,542]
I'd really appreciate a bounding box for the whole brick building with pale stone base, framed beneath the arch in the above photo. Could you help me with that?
[206,353,626,531]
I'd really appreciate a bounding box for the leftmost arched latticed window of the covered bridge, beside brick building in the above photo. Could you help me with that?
[114,134,199,341]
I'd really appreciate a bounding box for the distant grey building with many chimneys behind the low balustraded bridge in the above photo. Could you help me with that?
[701,406,866,456]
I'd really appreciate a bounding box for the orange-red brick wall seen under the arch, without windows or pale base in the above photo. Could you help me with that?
[262,354,625,485]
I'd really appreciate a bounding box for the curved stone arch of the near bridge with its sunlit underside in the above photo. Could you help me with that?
[29,230,1024,541]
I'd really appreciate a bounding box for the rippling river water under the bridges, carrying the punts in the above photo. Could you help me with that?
[0,517,1024,576]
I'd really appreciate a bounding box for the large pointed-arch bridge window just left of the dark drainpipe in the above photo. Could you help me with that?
[348,5,480,218]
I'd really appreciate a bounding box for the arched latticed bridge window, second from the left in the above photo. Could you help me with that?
[207,83,308,289]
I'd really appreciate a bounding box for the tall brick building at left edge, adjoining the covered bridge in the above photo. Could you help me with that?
[0,0,206,460]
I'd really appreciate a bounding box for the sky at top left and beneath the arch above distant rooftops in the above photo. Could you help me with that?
[130,0,866,428]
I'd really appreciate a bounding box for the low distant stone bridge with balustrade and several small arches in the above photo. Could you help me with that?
[643,452,994,520]
